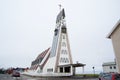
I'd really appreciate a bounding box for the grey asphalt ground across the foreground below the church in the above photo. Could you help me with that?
[0,74,98,80]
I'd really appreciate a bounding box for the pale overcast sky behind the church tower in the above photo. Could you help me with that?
[0,0,120,71]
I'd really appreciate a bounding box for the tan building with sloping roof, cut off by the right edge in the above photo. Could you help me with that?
[107,20,120,73]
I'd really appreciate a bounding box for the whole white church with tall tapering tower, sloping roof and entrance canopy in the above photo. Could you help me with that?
[26,9,85,76]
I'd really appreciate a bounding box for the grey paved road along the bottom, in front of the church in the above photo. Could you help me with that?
[0,74,98,80]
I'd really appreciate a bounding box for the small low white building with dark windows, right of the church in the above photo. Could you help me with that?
[102,62,118,72]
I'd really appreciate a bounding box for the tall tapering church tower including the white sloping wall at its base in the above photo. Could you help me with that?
[42,9,73,73]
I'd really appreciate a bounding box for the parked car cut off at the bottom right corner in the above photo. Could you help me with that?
[99,73,120,80]
